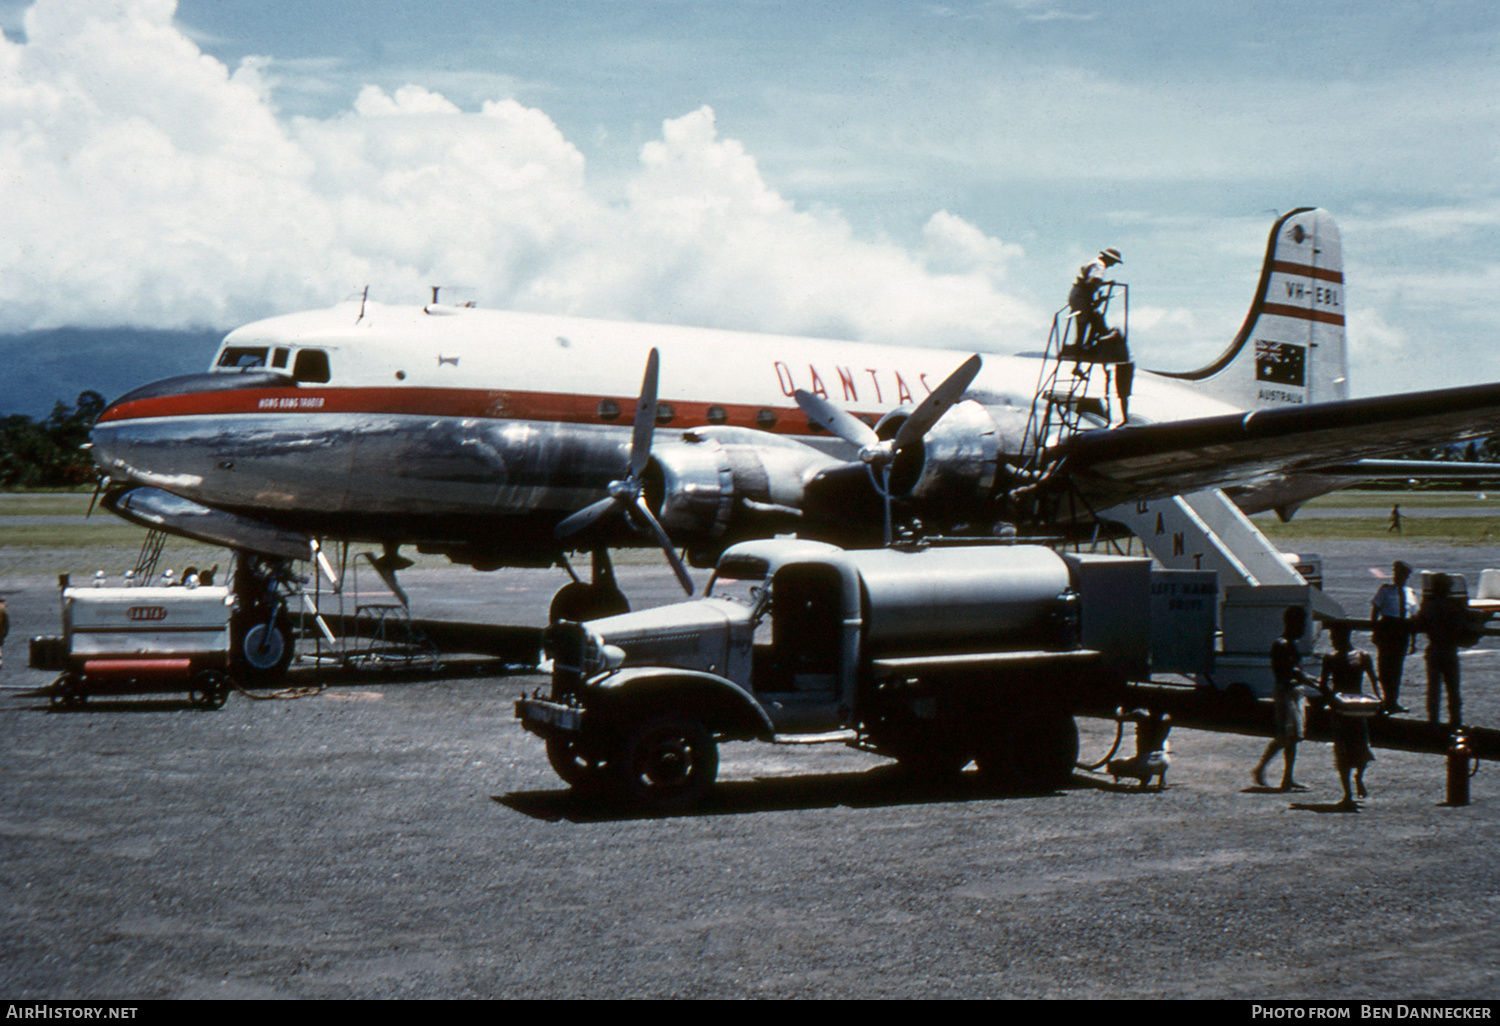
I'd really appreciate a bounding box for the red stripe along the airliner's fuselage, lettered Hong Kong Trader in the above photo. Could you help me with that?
[99,386,834,435]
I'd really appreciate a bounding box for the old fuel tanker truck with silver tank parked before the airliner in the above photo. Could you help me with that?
[516,539,1151,812]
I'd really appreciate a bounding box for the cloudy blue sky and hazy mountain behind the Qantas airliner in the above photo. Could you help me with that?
[0,0,1500,414]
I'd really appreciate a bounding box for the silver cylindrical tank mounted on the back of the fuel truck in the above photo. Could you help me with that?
[846,546,1076,654]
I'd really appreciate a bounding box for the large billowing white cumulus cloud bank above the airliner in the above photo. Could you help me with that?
[0,0,1041,348]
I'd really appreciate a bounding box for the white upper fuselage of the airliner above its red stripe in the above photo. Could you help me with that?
[215,303,1239,435]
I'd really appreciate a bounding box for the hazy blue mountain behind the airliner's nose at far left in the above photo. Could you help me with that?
[0,329,225,419]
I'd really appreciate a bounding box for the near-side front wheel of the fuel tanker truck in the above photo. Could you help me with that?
[614,713,719,812]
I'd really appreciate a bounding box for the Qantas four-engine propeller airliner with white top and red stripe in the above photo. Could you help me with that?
[93,209,1500,669]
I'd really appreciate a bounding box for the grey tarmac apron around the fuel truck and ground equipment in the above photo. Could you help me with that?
[0,543,1500,1001]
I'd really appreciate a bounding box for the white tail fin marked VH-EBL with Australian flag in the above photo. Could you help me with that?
[1157,207,1349,410]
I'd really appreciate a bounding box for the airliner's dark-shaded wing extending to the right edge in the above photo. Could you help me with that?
[1049,383,1500,506]
